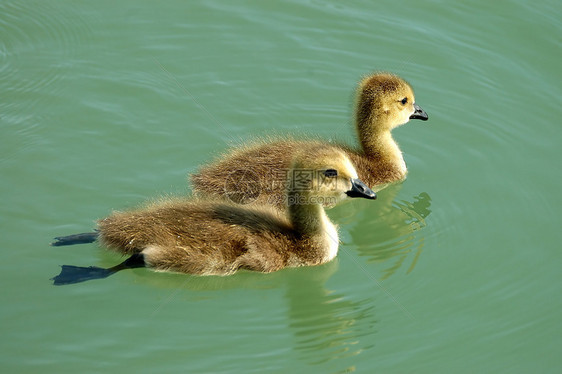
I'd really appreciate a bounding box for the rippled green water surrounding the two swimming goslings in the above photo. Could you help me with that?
[0,0,562,373]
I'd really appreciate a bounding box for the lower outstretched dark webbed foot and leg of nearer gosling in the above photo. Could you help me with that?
[51,254,145,286]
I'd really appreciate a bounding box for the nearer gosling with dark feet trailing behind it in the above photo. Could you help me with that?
[52,146,376,285]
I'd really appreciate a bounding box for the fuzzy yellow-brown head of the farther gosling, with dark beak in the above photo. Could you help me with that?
[356,73,429,135]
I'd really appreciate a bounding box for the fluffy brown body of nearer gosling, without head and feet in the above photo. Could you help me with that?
[98,201,330,275]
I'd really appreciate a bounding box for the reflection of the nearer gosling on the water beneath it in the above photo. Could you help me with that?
[97,254,377,372]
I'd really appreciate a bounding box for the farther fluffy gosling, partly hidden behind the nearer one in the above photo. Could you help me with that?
[191,73,428,208]
